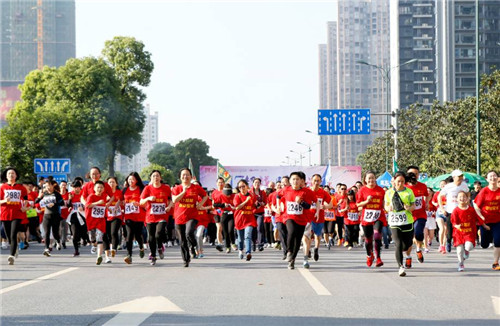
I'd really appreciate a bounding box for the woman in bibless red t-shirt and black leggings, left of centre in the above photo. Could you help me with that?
[172,168,208,267]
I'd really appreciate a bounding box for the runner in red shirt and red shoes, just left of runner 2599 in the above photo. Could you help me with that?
[356,171,387,267]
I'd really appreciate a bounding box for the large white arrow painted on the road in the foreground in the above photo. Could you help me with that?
[95,296,184,326]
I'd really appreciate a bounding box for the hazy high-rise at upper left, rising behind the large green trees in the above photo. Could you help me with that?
[0,0,76,124]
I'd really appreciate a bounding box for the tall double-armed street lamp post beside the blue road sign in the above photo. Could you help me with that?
[356,59,418,171]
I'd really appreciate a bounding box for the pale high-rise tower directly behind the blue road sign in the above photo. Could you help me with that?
[320,0,389,165]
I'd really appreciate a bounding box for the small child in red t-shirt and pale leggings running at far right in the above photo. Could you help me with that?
[450,191,490,272]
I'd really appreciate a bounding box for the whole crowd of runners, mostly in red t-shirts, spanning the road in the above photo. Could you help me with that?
[0,166,500,276]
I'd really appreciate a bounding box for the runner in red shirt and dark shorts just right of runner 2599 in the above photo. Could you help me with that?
[406,165,432,263]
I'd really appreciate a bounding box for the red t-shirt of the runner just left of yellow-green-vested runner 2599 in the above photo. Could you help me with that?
[356,186,387,225]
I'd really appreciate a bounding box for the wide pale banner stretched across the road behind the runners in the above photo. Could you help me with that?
[200,165,361,189]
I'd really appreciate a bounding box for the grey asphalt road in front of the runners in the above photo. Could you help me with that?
[0,243,500,325]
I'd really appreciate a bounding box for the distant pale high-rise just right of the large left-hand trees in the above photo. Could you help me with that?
[115,104,158,174]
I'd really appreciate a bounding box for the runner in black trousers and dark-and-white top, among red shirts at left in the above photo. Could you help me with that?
[35,180,65,257]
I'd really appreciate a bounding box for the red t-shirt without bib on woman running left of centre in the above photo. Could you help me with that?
[172,184,207,225]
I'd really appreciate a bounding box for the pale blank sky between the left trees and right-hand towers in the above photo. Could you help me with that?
[76,0,336,166]
